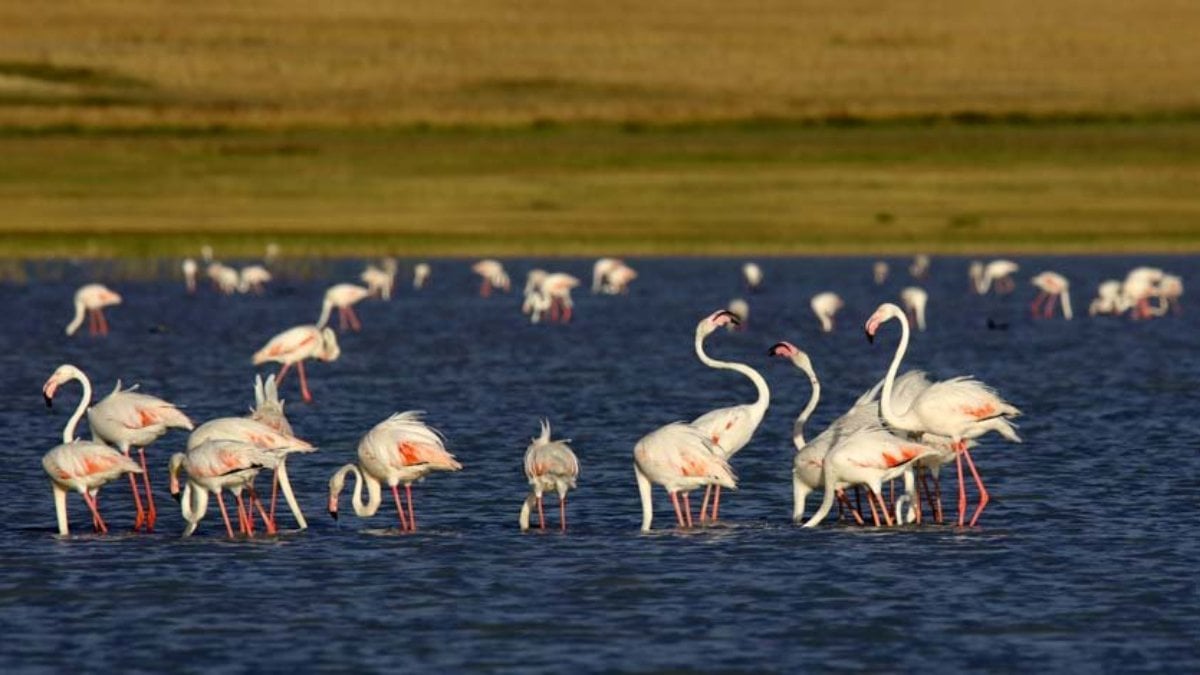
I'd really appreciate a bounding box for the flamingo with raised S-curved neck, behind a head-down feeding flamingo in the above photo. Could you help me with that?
[691,310,770,521]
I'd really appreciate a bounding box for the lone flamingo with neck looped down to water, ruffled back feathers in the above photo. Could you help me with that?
[329,411,462,532]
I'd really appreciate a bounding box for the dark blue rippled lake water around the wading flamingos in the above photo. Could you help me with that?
[0,257,1200,673]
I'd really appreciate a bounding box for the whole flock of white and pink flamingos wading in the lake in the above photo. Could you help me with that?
[42,251,1183,537]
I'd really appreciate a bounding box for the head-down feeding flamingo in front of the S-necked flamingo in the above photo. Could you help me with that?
[634,422,738,532]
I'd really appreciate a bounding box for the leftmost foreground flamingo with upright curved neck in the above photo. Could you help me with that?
[42,374,142,537]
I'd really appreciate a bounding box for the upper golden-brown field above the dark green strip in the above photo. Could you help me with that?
[7,0,1200,127]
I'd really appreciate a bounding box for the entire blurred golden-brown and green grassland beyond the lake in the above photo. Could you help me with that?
[0,0,1200,256]
